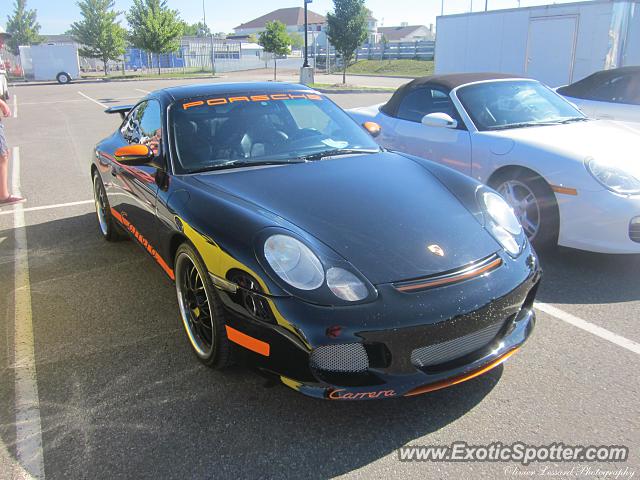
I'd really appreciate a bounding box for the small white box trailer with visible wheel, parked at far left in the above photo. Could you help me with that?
[18,45,80,83]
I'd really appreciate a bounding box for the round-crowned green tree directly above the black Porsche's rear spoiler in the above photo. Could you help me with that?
[127,0,184,75]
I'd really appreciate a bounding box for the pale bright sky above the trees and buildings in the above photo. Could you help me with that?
[0,0,592,35]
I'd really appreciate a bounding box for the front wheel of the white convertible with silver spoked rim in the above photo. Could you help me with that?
[491,169,560,250]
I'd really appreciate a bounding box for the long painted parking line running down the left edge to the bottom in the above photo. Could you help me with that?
[12,147,44,478]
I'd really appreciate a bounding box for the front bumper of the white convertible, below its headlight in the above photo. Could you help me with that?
[556,189,640,253]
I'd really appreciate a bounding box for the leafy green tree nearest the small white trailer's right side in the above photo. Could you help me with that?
[71,0,126,75]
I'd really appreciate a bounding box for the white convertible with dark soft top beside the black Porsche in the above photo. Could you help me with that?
[349,74,640,253]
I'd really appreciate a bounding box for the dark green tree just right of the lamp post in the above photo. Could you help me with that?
[327,0,368,83]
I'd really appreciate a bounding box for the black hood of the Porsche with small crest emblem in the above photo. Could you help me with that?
[190,152,500,284]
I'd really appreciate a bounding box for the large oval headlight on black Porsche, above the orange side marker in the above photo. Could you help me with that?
[264,234,324,290]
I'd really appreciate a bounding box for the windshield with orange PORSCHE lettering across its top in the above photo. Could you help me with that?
[170,90,379,173]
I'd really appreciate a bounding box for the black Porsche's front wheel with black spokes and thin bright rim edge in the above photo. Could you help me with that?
[174,243,233,369]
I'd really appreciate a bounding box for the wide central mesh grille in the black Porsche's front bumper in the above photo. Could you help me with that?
[411,323,503,368]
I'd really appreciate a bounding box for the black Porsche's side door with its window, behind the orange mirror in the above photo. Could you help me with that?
[108,99,165,247]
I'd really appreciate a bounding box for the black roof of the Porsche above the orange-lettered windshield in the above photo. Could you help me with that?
[158,82,315,100]
